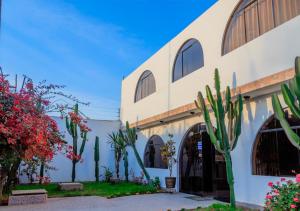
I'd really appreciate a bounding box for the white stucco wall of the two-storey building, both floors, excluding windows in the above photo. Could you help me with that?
[121,0,300,205]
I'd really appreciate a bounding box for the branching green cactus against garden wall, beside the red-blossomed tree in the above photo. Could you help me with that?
[66,104,87,182]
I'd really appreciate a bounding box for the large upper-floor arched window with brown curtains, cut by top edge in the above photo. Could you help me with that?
[222,0,300,55]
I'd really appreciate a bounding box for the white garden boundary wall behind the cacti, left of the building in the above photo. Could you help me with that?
[45,117,120,182]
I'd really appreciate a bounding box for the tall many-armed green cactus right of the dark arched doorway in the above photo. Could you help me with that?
[195,69,243,208]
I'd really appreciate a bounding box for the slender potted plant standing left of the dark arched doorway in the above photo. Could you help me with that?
[161,134,177,188]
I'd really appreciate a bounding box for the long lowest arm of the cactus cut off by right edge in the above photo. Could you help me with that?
[272,95,300,149]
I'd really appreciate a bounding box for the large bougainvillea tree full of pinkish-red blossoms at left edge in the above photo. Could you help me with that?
[0,74,64,196]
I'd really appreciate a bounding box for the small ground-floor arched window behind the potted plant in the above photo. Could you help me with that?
[144,135,167,169]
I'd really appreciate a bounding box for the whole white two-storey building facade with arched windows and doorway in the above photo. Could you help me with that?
[121,0,300,205]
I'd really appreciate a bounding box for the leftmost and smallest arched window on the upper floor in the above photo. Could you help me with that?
[134,70,156,102]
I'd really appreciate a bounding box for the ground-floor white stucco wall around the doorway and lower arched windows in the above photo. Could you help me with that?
[129,92,293,205]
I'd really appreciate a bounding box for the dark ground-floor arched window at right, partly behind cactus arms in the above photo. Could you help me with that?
[253,111,300,176]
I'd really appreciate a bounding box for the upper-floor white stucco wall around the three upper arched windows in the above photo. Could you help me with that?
[121,0,300,123]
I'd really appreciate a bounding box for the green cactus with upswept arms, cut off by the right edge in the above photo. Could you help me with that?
[272,57,300,149]
